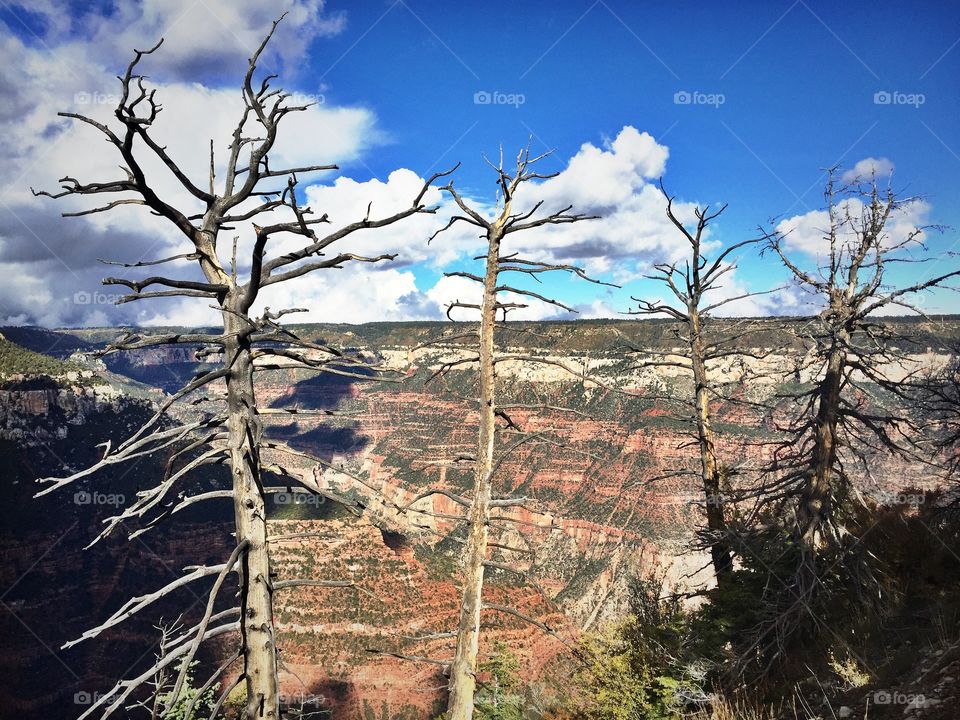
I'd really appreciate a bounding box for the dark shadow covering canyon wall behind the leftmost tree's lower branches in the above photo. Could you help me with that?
[0,405,233,720]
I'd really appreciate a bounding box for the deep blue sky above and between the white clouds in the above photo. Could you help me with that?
[0,0,960,321]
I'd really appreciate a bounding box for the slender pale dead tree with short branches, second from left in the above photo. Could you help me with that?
[431,146,612,720]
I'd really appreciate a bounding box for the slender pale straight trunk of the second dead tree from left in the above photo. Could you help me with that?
[447,225,501,720]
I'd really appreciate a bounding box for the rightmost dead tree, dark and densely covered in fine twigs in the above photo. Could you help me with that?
[751,168,960,656]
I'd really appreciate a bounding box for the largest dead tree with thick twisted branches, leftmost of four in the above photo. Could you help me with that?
[35,17,447,720]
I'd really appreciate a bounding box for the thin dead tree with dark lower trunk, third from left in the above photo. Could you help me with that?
[629,179,773,585]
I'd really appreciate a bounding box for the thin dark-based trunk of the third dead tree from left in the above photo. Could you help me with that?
[688,306,733,585]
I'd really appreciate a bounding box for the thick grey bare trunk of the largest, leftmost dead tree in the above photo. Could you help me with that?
[224,306,280,720]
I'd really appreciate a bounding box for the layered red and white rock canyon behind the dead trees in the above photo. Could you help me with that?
[0,318,960,719]
